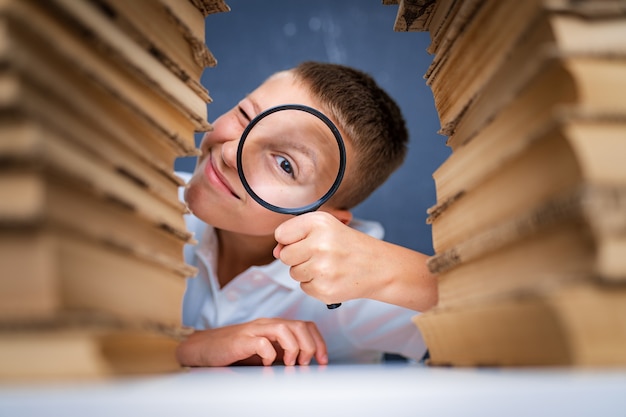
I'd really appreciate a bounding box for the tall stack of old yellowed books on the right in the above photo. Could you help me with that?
[386,0,626,366]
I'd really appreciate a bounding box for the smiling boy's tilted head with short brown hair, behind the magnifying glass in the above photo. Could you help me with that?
[185,62,408,235]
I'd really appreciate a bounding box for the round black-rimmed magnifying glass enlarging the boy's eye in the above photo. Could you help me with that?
[237,104,346,309]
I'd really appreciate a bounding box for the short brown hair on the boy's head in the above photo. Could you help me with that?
[292,62,409,209]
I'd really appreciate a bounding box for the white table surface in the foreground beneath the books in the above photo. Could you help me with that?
[0,363,626,417]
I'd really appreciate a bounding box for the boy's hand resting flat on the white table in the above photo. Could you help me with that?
[176,318,328,366]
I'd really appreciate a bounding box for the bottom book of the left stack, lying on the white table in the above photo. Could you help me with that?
[0,313,189,382]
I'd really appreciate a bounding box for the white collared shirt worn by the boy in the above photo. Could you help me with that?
[181,175,426,363]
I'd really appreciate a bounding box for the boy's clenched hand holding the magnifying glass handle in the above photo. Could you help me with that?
[274,211,384,304]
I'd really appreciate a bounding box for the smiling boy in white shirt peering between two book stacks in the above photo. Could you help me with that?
[178,62,436,366]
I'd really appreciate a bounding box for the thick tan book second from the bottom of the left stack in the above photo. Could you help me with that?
[0,224,186,326]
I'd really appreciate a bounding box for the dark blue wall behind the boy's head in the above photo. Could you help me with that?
[176,0,449,254]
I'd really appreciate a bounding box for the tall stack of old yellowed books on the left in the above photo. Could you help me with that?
[0,0,229,379]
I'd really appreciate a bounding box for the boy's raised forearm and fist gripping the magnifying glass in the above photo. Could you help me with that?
[274,211,438,311]
